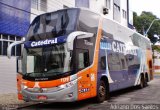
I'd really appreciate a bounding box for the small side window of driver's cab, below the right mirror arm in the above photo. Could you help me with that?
[77,49,89,70]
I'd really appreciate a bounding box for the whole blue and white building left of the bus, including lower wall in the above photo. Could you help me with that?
[0,0,31,93]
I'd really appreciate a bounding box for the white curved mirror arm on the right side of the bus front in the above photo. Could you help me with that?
[67,31,94,51]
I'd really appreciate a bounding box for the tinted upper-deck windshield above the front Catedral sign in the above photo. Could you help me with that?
[27,8,79,41]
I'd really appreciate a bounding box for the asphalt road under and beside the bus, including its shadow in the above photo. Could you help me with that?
[20,75,160,110]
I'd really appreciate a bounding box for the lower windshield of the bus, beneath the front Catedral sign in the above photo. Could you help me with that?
[26,44,71,78]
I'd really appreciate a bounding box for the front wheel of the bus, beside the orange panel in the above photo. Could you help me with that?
[96,80,106,103]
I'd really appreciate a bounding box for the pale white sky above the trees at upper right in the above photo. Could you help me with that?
[130,0,160,18]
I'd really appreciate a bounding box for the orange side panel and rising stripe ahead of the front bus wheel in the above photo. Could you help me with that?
[78,20,102,100]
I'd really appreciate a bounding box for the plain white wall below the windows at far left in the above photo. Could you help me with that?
[0,56,17,94]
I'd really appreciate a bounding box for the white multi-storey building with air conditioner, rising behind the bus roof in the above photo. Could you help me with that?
[31,0,133,28]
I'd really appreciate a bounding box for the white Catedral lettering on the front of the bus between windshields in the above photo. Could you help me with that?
[31,38,57,47]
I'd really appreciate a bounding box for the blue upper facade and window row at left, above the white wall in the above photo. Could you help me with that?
[0,0,31,56]
